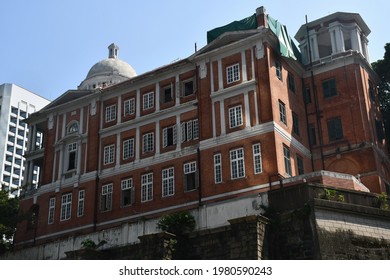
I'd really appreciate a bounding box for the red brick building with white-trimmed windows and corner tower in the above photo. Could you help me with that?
[15,8,390,249]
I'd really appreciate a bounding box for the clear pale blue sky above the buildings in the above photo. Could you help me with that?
[0,0,390,100]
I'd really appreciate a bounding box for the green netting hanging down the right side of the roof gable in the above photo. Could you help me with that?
[267,15,301,61]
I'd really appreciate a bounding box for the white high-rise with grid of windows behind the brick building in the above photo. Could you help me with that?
[0,83,50,195]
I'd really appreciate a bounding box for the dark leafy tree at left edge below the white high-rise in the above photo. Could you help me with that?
[0,189,19,254]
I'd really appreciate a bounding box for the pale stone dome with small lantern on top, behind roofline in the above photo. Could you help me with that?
[79,44,137,90]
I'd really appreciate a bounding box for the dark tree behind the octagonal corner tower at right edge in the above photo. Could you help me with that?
[372,43,390,152]
